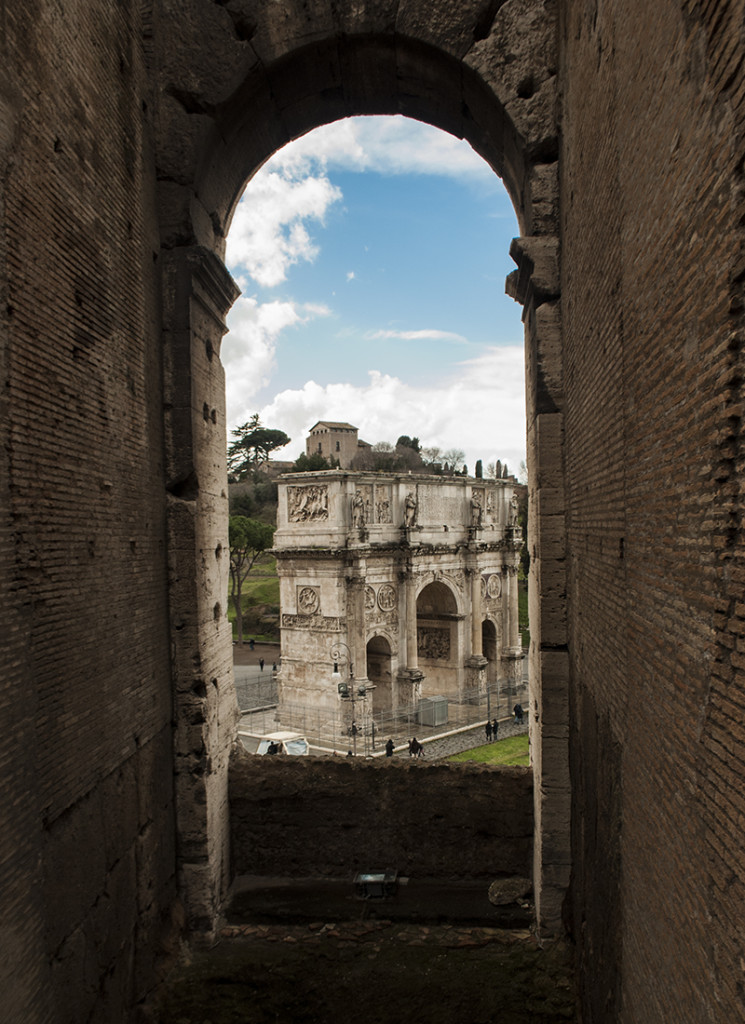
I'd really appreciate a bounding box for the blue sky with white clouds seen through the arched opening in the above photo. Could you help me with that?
[222,118,525,472]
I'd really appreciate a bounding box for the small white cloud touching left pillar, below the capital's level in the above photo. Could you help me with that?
[220,296,331,427]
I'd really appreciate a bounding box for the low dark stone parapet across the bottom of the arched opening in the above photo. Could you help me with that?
[230,753,533,880]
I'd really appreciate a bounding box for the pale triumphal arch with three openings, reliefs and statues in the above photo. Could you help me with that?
[274,471,523,713]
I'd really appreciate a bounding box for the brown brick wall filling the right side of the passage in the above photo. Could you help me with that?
[561,0,745,1024]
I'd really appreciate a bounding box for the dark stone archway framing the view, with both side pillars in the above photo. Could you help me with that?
[150,0,569,931]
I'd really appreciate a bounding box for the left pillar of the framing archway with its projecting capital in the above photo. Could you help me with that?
[162,246,239,935]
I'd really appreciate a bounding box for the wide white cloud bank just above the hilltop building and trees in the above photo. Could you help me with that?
[252,345,525,473]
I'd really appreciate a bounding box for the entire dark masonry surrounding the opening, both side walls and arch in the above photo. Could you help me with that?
[8,0,745,1024]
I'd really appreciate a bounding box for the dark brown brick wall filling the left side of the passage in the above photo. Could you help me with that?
[0,0,176,1024]
